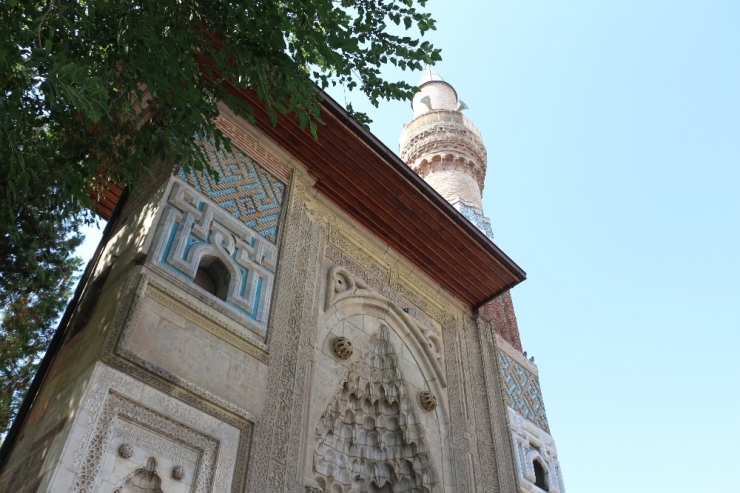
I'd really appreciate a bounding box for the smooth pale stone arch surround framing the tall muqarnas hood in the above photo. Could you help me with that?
[306,267,452,491]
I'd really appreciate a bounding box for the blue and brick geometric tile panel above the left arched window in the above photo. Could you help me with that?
[178,141,285,243]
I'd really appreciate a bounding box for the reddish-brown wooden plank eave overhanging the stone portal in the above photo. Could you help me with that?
[89,77,526,308]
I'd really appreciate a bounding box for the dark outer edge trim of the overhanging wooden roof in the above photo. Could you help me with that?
[319,91,527,294]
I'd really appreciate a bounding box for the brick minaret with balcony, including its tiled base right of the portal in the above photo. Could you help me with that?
[400,66,565,493]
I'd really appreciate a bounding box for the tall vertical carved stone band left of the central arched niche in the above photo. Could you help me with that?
[248,175,325,492]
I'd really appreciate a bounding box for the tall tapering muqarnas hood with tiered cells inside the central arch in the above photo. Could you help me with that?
[314,326,438,493]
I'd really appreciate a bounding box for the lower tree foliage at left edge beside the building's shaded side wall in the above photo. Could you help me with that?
[0,202,82,436]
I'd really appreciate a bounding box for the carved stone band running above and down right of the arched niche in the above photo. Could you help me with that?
[304,193,516,492]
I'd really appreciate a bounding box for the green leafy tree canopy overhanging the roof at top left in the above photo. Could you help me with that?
[0,0,440,235]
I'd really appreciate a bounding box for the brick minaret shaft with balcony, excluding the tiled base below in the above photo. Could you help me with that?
[400,66,522,351]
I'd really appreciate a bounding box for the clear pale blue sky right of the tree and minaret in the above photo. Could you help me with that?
[76,0,740,493]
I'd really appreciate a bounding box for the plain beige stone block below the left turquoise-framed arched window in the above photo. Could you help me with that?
[104,266,269,422]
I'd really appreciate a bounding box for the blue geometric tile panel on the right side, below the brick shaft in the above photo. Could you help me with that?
[498,351,550,433]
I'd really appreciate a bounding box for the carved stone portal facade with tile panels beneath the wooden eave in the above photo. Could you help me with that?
[0,67,564,493]
